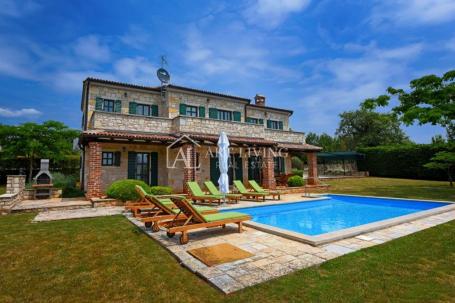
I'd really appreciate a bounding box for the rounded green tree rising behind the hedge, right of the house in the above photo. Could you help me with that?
[336,108,411,150]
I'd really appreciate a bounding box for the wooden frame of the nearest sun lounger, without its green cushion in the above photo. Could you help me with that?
[167,199,251,244]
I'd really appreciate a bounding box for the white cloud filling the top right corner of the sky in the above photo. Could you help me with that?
[370,0,455,27]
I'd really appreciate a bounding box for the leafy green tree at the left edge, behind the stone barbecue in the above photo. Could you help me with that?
[0,121,79,182]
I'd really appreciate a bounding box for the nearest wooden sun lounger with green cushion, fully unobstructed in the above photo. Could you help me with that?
[167,198,251,244]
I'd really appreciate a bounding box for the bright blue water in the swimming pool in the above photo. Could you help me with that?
[226,195,448,236]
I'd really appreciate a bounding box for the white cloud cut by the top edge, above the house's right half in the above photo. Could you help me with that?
[245,0,310,28]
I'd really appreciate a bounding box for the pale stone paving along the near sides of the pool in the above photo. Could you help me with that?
[125,209,455,294]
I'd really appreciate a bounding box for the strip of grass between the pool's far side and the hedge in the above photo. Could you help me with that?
[327,177,455,201]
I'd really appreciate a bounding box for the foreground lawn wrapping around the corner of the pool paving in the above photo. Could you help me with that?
[0,179,455,302]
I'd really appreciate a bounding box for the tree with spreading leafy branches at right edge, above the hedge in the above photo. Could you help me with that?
[362,70,455,142]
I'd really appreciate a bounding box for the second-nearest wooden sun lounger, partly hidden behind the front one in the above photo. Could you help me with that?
[136,185,218,232]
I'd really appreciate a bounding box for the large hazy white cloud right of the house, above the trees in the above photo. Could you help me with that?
[296,42,423,133]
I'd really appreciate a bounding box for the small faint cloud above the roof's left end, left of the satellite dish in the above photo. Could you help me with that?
[74,35,110,62]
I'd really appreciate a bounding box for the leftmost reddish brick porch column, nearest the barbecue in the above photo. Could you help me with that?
[85,142,104,199]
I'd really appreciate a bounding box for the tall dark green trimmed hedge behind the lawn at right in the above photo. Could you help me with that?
[358,144,455,181]
